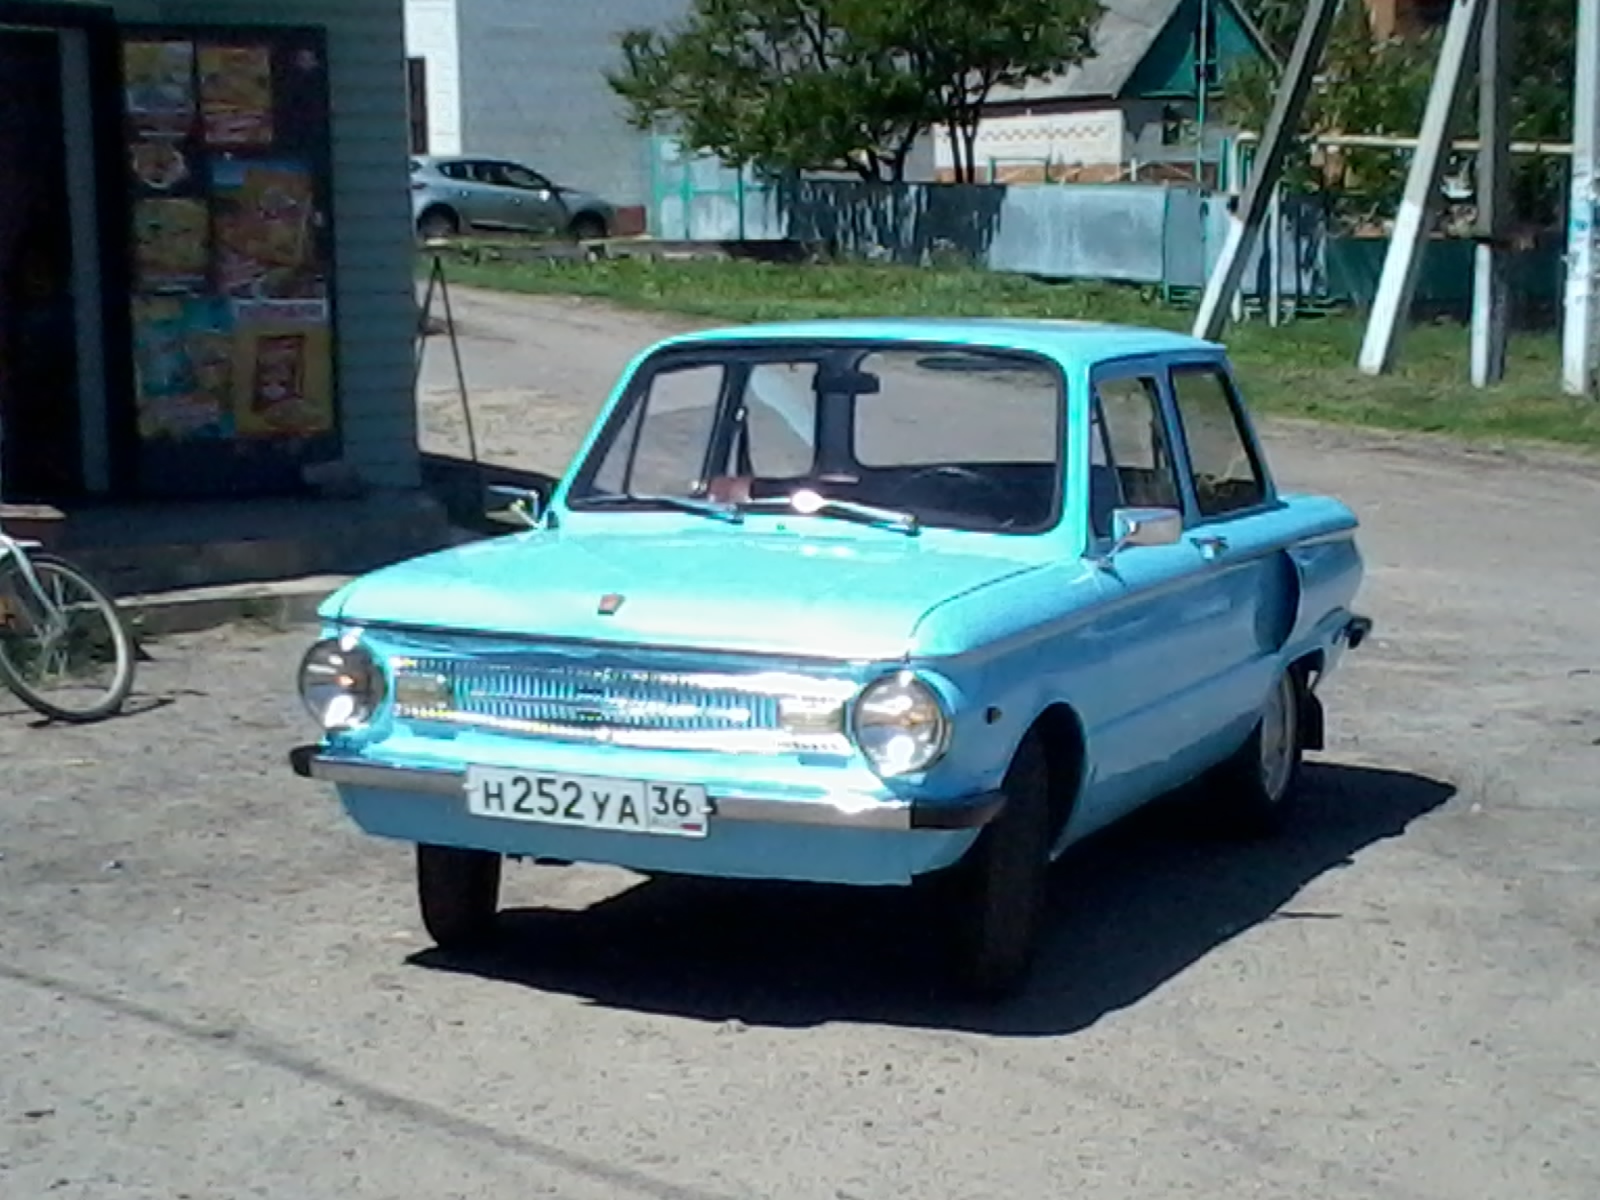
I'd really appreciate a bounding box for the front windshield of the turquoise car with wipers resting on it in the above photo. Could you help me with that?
[566,342,1064,533]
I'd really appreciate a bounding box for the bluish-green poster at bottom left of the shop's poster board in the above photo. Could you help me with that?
[133,296,234,438]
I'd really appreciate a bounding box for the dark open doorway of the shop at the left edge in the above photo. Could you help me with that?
[0,29,83,502]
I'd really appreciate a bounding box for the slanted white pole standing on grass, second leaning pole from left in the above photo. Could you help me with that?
[1357,0,1488,374]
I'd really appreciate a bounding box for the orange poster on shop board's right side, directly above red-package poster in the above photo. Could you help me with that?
[211,162,328,299]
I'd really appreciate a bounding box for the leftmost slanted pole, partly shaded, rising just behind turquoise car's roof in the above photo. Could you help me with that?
[1194,0,1339,341]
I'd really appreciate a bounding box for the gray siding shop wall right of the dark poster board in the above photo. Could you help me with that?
[152,0,421,488]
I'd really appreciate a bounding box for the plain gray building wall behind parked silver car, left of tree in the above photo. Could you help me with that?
[459,0,688,205]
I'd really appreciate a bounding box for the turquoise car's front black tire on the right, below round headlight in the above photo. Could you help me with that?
[947,733,1053,1002]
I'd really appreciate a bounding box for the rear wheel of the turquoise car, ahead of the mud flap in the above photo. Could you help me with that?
[1206,667,1306,838]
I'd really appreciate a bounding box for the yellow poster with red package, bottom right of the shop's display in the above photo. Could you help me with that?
[234,322,334,437]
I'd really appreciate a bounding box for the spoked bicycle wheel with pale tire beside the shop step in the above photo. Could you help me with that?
[0,554,133,725]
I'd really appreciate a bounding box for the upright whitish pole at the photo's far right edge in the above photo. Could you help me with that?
[1562,0,1600,395]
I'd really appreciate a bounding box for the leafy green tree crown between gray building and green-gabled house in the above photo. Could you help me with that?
[608,0,1101,181]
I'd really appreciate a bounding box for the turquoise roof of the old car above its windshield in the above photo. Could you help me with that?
[649,317,1222,363]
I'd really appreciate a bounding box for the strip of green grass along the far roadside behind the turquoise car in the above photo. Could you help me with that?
[448,258,1600,450]
